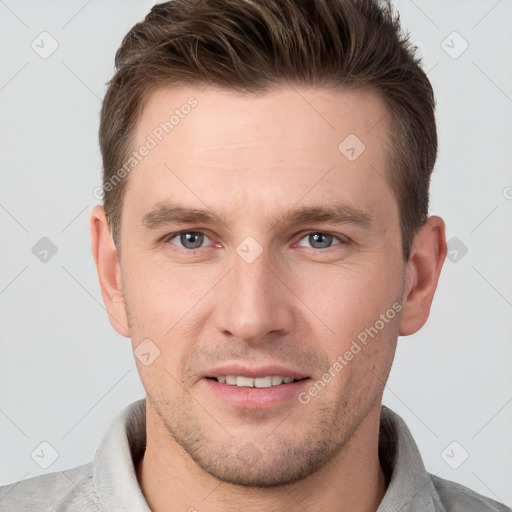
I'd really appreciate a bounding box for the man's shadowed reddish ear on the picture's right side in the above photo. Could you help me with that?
[399,216,446,336]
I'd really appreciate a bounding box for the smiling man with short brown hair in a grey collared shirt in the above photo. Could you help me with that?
[0,0,507,512]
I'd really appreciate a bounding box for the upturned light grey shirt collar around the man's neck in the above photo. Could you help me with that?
[93,399,443,512]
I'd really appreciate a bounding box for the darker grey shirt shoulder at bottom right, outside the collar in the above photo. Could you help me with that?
[431,475,512,512]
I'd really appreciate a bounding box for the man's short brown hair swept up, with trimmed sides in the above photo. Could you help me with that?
[99,0,437,260]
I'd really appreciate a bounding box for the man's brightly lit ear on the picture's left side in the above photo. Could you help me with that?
[90,205,130,338]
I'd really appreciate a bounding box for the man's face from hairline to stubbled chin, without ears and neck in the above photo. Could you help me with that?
[120,87,405,486]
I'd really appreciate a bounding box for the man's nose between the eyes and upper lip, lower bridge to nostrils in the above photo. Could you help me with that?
[216,244,294,344]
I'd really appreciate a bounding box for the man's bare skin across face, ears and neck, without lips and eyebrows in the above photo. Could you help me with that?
[91,86,446,512]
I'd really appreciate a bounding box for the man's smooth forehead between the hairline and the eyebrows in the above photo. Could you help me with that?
[122,86,392,224]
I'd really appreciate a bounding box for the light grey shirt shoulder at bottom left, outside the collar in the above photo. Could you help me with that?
[0,463,102,512]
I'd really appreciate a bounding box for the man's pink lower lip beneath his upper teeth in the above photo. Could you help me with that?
[202,379,311,409]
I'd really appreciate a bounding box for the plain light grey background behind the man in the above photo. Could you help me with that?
[0,0,512,506]
